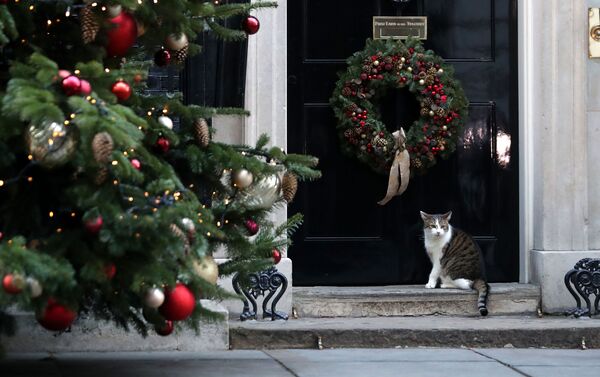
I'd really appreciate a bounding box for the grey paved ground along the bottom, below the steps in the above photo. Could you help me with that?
[0,348,600,377]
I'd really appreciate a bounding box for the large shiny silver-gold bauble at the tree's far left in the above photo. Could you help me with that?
[27,122,77,168]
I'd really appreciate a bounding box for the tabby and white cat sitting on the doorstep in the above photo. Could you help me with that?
[421,211,490,316]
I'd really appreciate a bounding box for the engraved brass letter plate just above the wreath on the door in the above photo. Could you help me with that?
[373,16,427,39]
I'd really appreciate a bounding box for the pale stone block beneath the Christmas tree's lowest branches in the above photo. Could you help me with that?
[0,300,229,353]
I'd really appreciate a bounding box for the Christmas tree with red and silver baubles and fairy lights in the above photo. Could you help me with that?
[0,0,319,344]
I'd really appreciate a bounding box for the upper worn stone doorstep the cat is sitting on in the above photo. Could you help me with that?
[293,283,540,318]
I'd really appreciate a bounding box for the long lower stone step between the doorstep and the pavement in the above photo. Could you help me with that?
[230,316,600,349]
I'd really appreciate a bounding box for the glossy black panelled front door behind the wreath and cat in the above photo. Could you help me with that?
[288,0,519,285]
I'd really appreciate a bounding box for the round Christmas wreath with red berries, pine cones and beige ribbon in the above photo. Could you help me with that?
[330,39,468,204]
